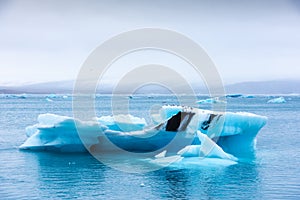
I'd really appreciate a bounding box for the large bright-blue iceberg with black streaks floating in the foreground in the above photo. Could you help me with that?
[20,106,267,165]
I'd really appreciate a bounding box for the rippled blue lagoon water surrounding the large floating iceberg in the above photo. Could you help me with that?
[0,95,300,199]
